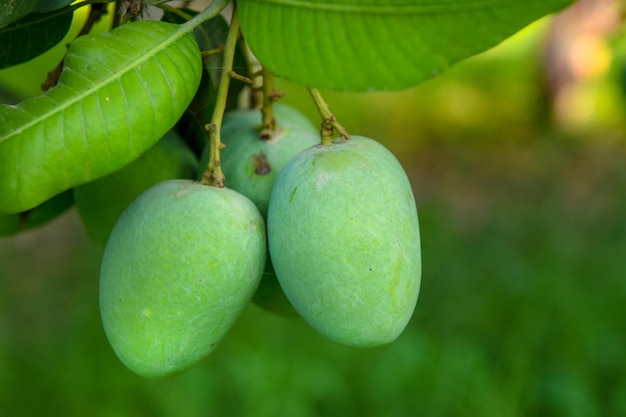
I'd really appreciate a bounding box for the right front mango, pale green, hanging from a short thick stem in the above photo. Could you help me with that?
[267,136,422,347]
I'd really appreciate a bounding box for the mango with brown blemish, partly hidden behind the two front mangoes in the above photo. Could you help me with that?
[200,104,320,316]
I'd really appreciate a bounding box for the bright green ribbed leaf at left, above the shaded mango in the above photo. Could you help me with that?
[0,21,202,214]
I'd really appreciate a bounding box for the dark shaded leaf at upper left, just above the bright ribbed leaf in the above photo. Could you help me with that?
[0,7,74,69]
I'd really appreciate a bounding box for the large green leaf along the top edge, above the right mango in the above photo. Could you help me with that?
[237,0,573,91]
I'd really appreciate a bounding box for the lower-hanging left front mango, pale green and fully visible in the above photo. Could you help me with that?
[100,180,267,378]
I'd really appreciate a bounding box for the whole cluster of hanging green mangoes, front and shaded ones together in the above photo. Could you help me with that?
[85,105,421,377]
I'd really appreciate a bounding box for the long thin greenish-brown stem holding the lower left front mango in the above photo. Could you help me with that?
[201,4,239,188]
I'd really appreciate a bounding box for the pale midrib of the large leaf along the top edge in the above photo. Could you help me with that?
[239,0,510,15]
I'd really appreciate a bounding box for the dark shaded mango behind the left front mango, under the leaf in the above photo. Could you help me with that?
[74,131,198,247]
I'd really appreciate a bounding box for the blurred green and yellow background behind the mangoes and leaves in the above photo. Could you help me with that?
[0,2,626,417]
